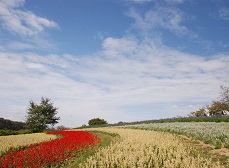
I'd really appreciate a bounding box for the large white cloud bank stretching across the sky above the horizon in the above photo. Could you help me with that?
[0,37,229,127]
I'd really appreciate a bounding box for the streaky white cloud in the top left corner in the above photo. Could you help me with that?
[0,0,57,36]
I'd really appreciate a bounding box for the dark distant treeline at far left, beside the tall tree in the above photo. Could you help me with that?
[0,118,25,131]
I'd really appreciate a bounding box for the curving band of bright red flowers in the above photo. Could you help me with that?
[0,131,100,168]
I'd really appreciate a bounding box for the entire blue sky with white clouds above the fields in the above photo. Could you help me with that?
[0,0,229,127]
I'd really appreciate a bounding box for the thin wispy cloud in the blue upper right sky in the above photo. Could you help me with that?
[127,5,220,53]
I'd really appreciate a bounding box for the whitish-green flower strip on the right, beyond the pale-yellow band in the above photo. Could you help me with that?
[120,122,229,149]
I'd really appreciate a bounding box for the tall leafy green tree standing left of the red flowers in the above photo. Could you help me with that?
[26,97,60,132]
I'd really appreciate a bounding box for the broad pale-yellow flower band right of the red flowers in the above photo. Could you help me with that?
[80,128,223,168]
